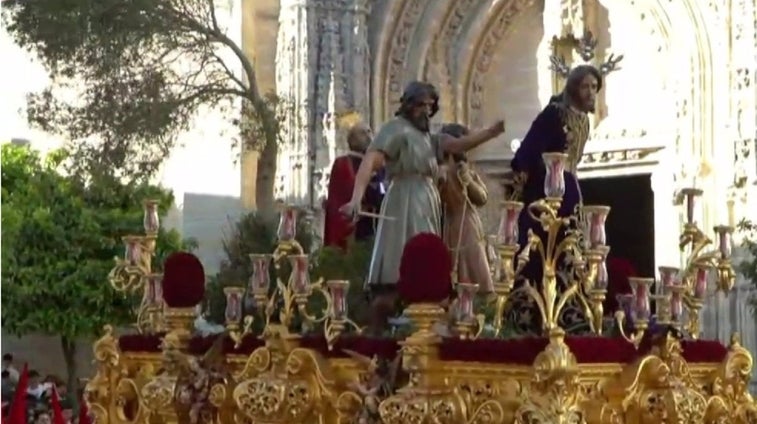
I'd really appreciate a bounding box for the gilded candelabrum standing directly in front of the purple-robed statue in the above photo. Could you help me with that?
[494,153,610,334]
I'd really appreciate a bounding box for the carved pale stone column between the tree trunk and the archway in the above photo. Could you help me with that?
[276,0,370,215]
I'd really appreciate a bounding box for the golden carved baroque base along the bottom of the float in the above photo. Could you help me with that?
[85,326,757,424]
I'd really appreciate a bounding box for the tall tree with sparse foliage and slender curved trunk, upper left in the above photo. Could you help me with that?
[3,0,283,211]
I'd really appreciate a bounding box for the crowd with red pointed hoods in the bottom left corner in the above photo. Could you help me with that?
[2,353,90,424]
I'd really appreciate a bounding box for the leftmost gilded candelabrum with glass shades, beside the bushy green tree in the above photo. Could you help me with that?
[108,200,164,333]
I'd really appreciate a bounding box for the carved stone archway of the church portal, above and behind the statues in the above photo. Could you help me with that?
[372,0,714,164]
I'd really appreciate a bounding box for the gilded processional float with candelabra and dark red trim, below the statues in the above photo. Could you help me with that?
[85,153,757,424]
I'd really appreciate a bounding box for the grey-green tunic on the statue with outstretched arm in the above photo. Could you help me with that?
[366,117,442,285]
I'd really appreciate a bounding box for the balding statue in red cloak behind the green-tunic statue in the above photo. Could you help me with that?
[323,123,385,249]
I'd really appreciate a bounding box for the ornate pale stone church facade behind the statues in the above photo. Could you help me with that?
[251,0,757,384]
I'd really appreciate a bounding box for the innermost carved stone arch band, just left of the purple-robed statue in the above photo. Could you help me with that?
[463,0,534,128]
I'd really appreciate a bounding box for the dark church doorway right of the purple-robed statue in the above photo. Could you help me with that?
[580,174,655,276]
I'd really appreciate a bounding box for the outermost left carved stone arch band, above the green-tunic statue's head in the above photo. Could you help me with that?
[382,0,428,119]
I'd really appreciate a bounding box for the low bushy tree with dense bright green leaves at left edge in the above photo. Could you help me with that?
[2,144,188,406]
